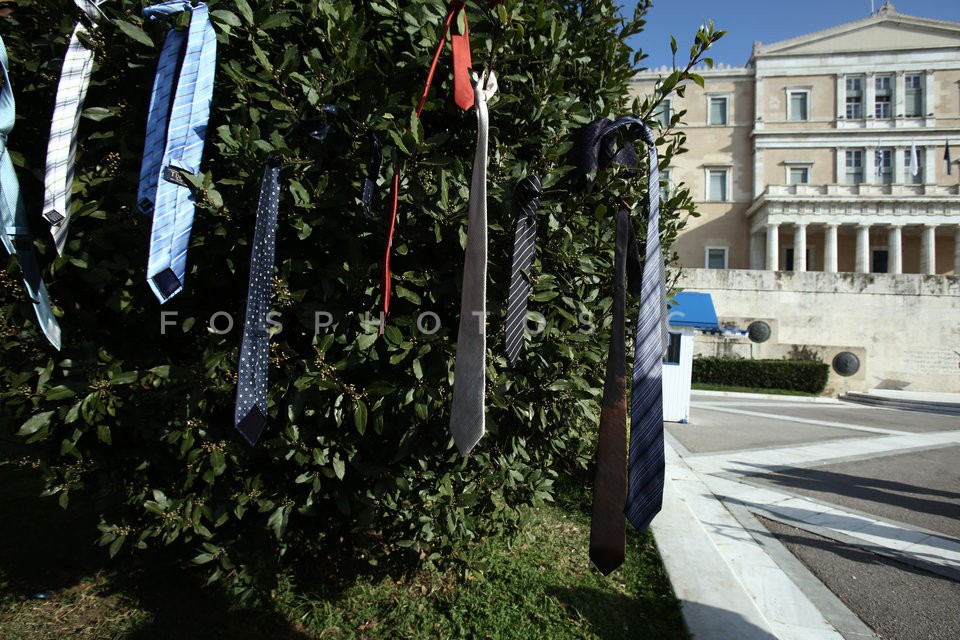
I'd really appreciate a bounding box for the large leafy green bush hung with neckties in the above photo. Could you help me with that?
[0,0,715,593]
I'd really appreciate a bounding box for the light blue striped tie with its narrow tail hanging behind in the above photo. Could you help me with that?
[137,2,217,303]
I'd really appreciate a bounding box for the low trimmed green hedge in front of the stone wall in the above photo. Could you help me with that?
[693,357,830,393]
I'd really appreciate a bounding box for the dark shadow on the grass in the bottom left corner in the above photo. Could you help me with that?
[0,466,313,640]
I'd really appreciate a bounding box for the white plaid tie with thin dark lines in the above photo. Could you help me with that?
[43,0,106,255]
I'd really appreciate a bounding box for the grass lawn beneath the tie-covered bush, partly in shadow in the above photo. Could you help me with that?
[0,467,688,640]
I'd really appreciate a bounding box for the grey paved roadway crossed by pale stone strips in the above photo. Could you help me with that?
[667,394,960,640]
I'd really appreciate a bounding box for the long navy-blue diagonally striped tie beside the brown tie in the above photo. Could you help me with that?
[625,121,667,531]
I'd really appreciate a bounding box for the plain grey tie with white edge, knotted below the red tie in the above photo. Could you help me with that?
[450,71,497,455]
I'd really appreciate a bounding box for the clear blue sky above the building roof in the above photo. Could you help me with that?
[623,0,960,68]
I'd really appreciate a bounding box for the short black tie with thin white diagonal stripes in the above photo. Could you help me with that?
[504,175,543,364]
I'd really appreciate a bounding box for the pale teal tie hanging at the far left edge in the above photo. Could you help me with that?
[0,39,60,349]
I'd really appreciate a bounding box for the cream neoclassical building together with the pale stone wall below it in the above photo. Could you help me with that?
[634,3,960,394]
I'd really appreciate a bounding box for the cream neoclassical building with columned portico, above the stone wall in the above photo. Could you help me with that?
[635,3,960,275]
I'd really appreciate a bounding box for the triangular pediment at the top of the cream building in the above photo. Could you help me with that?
[753,9,960,59]
